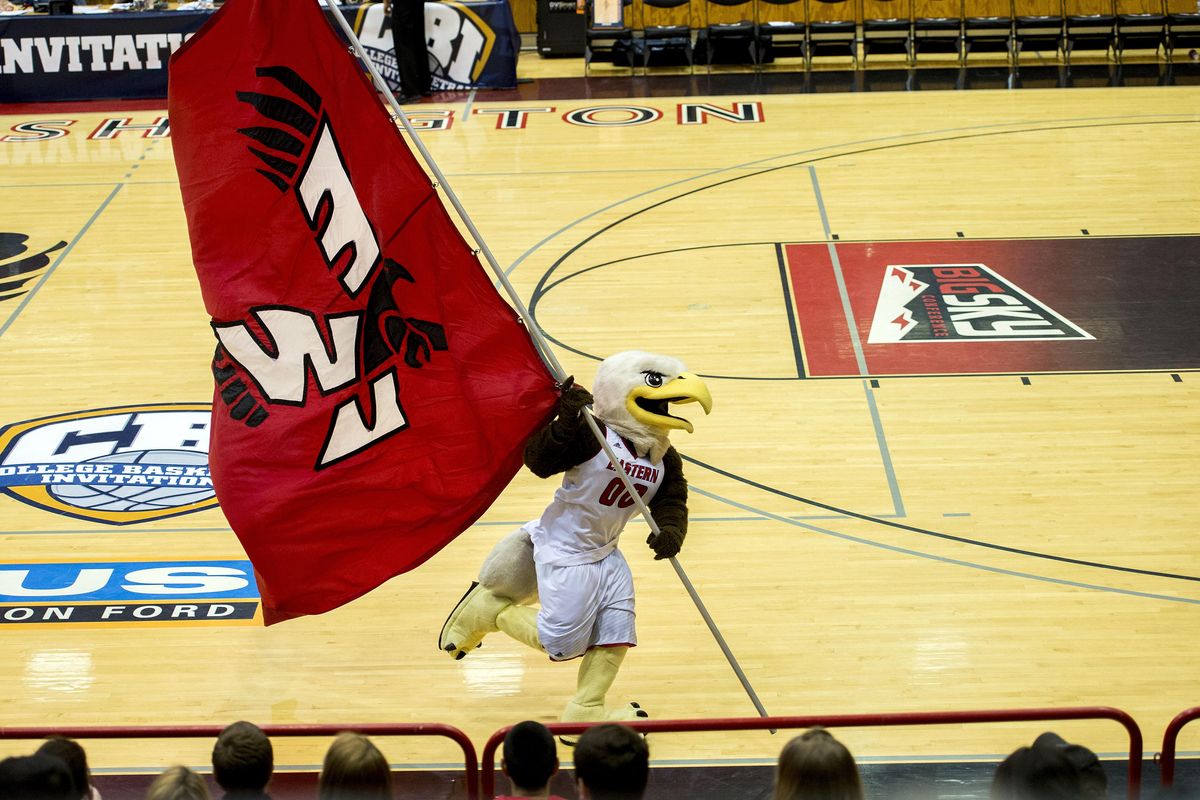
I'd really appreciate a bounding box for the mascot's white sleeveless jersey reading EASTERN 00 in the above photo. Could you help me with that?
[523,429,662,566]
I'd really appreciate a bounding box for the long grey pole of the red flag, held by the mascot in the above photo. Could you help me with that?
[319,0,774,733]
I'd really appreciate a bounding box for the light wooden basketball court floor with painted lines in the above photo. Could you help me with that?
[0,43,1200,796]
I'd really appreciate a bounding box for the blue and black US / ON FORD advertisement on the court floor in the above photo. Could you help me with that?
[0,561,258,625]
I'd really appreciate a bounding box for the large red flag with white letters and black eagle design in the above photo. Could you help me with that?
[168,0,557,624]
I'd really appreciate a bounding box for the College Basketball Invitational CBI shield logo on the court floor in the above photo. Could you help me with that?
[0,403,217,525]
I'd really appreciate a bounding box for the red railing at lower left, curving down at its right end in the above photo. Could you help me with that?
[0,722,477,800]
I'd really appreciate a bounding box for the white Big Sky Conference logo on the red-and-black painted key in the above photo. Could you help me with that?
[868,264,1093,344]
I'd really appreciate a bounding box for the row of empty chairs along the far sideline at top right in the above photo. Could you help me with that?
[584,0,1200,71]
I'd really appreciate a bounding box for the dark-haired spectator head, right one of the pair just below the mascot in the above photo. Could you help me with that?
[575,723,650,800]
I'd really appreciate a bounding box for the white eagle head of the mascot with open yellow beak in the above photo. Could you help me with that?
[592,350,713,463]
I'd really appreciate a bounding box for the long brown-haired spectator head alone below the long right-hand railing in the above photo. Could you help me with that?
[773,727,863,800]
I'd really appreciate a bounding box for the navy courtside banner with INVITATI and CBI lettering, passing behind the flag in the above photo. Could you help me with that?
[0,0,521,103]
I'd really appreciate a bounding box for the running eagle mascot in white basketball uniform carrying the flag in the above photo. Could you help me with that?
[438,350,713,722]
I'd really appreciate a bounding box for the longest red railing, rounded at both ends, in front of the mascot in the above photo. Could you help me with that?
[480,706,1142,800]
